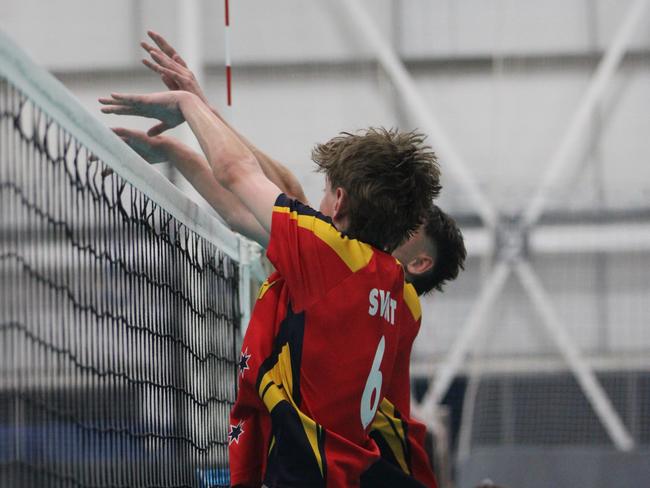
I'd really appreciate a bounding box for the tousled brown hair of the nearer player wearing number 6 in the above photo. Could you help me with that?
[312,127,441,252]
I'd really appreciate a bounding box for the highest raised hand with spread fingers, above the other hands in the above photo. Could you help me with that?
[140,31,209,105]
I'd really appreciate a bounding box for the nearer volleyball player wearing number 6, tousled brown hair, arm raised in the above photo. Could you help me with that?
[102,75,440,486]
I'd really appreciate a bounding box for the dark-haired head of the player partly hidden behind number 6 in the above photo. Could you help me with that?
[393,204,467,295]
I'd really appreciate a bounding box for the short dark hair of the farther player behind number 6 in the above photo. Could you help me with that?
[411,204,467,295]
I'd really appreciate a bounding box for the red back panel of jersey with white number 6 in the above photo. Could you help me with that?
[284,246,405,443]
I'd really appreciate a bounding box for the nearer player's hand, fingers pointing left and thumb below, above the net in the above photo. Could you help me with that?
[99,91,189,136]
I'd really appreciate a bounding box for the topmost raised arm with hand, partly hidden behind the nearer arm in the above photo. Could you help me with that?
[141,31,308,203]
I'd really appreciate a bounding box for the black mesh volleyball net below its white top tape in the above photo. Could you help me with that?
[0,79,239,487]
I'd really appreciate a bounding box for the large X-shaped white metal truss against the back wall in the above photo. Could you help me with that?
[340,0,650,451]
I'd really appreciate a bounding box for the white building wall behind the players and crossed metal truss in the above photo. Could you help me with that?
[0,0,650,368]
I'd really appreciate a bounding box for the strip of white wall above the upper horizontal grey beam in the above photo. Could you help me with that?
[5,0,650,69]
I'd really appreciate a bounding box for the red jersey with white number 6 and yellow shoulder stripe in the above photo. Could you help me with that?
[229,195,419,488]
